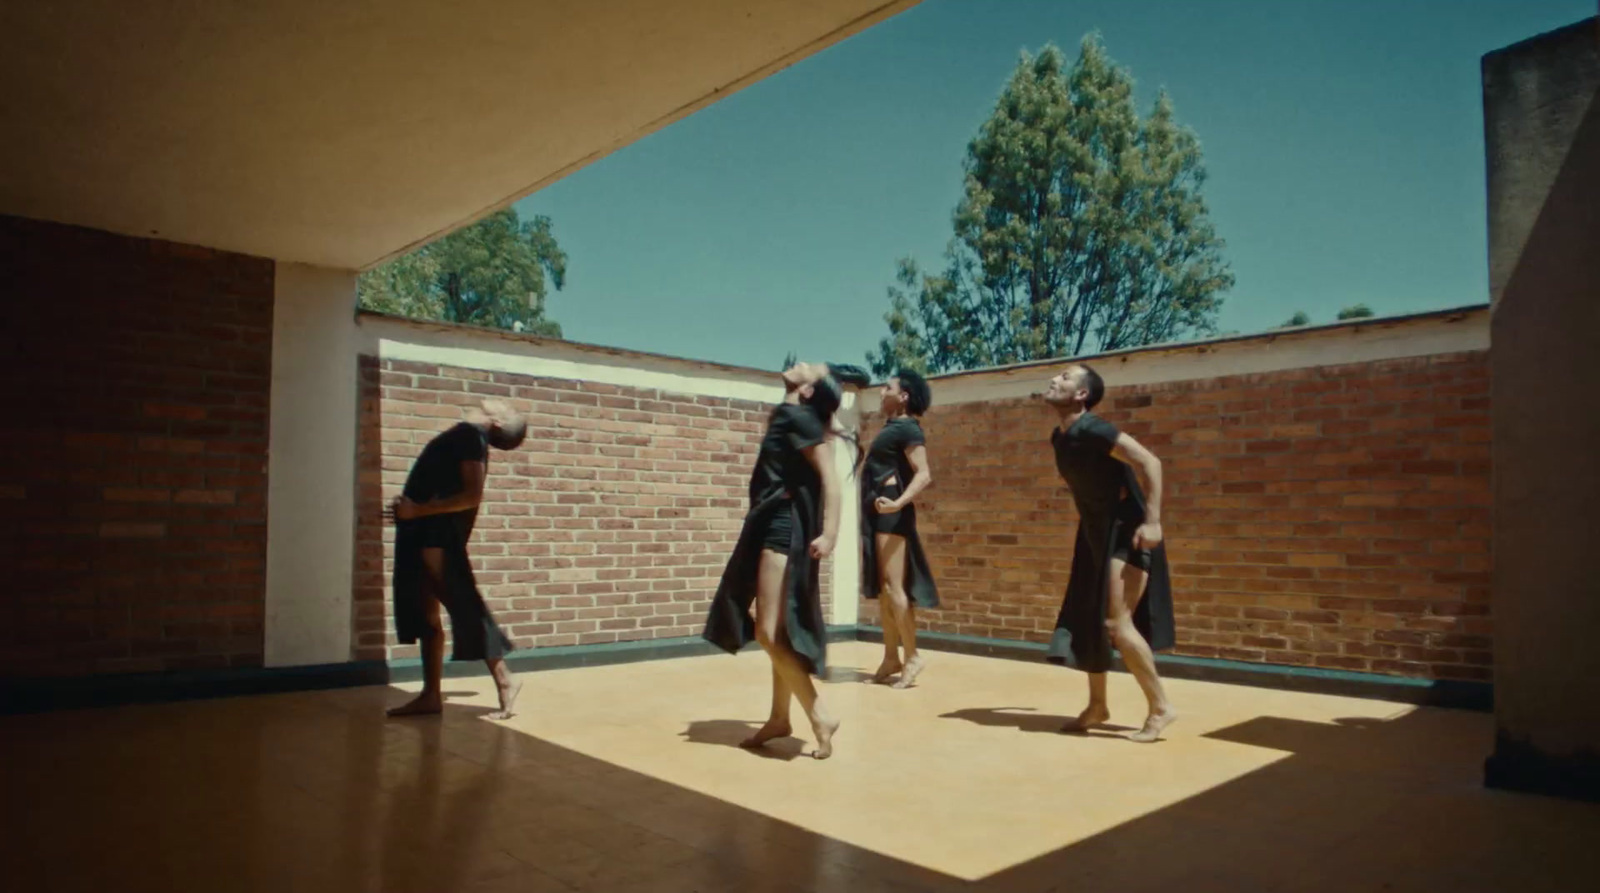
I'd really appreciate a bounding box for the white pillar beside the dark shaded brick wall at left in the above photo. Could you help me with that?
[266,262,357,667]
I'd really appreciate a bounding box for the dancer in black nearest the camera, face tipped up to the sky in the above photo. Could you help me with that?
[704,363,867,760]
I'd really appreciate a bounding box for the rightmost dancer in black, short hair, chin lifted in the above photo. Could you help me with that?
[1043,365,1178,741]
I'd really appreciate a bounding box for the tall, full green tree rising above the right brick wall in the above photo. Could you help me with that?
[867,35,1234,376]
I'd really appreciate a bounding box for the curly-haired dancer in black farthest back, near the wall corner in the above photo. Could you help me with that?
[861,370,939,688]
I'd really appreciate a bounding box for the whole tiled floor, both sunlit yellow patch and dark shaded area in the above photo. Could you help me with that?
[0,643,1600,893]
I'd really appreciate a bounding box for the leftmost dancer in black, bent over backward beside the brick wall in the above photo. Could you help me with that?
[386,400,526,719]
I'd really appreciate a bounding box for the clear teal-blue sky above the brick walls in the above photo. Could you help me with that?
[517,0,1595,368]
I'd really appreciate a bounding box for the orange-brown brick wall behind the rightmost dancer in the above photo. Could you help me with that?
[862,352,1491,680]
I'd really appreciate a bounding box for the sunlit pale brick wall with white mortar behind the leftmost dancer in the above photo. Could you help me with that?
[355,357,800,658]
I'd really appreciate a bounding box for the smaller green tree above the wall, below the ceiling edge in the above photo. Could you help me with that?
[357,208,566,338]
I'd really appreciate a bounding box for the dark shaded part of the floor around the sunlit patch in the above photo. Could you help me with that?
[0,690,1600,893]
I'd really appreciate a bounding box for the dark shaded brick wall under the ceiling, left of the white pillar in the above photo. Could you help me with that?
[0,218,274,677]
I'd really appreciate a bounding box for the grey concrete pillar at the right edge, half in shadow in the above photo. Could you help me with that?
[1483,19,1600,800]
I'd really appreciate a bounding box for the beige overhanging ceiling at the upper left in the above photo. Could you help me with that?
[0,0,917,267]
